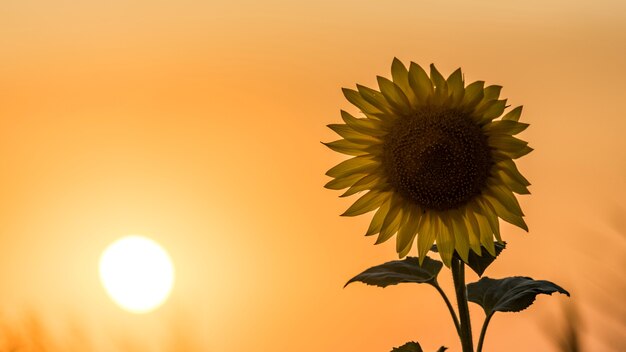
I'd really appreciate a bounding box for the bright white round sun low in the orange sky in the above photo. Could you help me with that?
[100,235,174,313]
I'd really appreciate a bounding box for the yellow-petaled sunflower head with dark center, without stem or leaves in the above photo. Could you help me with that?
[324,59,532,266]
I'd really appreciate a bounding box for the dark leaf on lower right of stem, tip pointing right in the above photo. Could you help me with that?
[467,276,569,316]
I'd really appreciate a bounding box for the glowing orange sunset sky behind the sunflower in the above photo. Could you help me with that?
[0,0,626,352]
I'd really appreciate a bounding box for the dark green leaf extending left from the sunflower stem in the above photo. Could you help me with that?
[344,257,443,287]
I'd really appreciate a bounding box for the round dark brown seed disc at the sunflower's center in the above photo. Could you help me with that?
[382,108,493,210]
